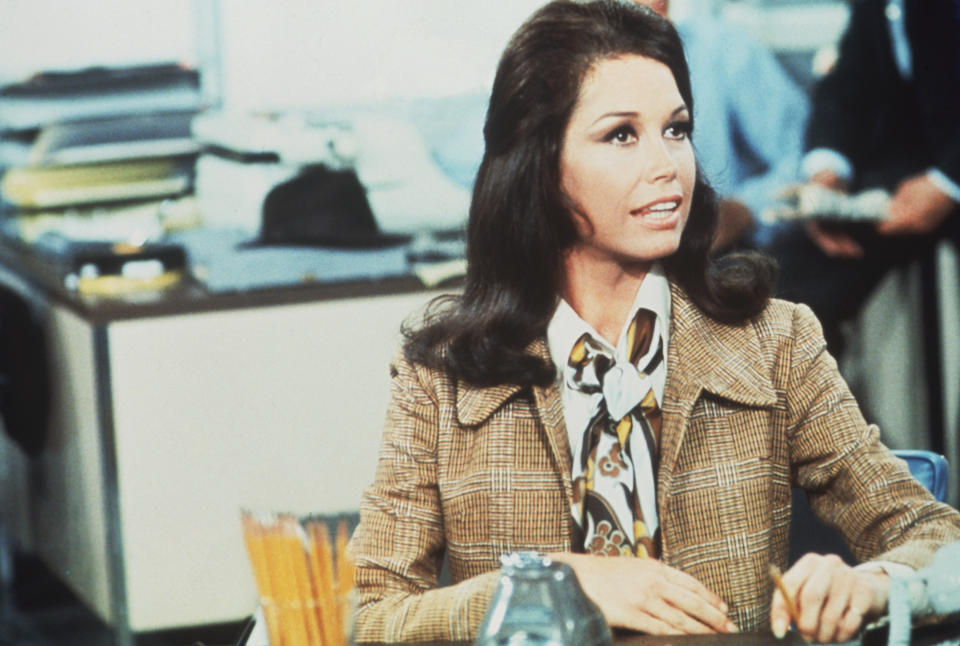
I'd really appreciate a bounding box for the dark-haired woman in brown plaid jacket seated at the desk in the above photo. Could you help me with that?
[353,0,960,642]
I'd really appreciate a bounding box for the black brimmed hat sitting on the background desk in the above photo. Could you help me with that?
[255,165,410,247]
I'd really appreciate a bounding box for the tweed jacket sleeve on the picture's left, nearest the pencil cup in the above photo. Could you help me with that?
[351,357,497,642]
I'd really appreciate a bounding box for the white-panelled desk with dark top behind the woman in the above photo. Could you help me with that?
[0,244,450,644]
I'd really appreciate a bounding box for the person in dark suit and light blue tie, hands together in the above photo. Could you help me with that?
[769,0,960,355]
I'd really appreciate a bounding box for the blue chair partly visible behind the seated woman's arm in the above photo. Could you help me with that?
[789,450,948,564]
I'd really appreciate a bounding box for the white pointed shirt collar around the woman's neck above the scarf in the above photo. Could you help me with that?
[547,263,672,382]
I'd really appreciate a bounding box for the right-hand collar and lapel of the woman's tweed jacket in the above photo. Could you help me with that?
[657,284,777,522]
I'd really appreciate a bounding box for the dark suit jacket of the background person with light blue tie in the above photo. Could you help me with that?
[807,0,960,190]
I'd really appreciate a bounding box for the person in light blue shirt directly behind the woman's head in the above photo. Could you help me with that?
[635,0,809,248]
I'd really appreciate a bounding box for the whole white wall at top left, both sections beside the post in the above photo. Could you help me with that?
[0,0,543,109]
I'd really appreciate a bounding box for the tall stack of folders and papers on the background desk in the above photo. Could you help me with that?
[0,64,201,291]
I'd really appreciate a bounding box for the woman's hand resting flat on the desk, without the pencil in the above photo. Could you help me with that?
[550,553,737,635]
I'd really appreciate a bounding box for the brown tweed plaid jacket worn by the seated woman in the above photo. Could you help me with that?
[351,287,960,642]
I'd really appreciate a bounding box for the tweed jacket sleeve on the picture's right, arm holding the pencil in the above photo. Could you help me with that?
[787,305,960,568]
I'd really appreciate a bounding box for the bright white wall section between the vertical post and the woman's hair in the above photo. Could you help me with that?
[220,0,542,108]
